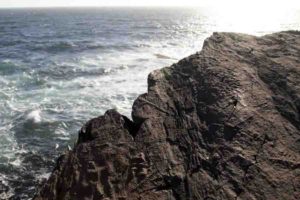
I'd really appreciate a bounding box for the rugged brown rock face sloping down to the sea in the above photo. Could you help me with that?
[35,31,300,200]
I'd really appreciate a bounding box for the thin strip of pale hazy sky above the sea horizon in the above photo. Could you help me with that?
[0,0,300,9]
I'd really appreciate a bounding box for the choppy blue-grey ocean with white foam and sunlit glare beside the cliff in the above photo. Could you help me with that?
[0,8,300,199]
